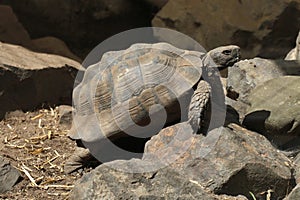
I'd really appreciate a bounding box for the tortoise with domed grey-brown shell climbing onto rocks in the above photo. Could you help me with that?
[65,42,240,172]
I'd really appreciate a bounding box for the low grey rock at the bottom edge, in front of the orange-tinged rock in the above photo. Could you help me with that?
[70,159,246,200]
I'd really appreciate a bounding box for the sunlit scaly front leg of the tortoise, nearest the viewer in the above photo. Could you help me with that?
[188,80,211,133]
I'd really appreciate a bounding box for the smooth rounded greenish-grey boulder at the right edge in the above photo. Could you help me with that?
[243,76,300,149]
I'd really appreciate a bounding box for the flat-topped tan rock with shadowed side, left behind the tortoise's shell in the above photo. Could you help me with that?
[0,40,83,118]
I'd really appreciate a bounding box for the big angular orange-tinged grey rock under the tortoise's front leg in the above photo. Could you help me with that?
[143,124,294,199]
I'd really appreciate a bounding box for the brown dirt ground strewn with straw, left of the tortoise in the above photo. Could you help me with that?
[0,108,89,200]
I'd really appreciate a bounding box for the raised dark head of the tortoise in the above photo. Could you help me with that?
[204,45,240,68]
